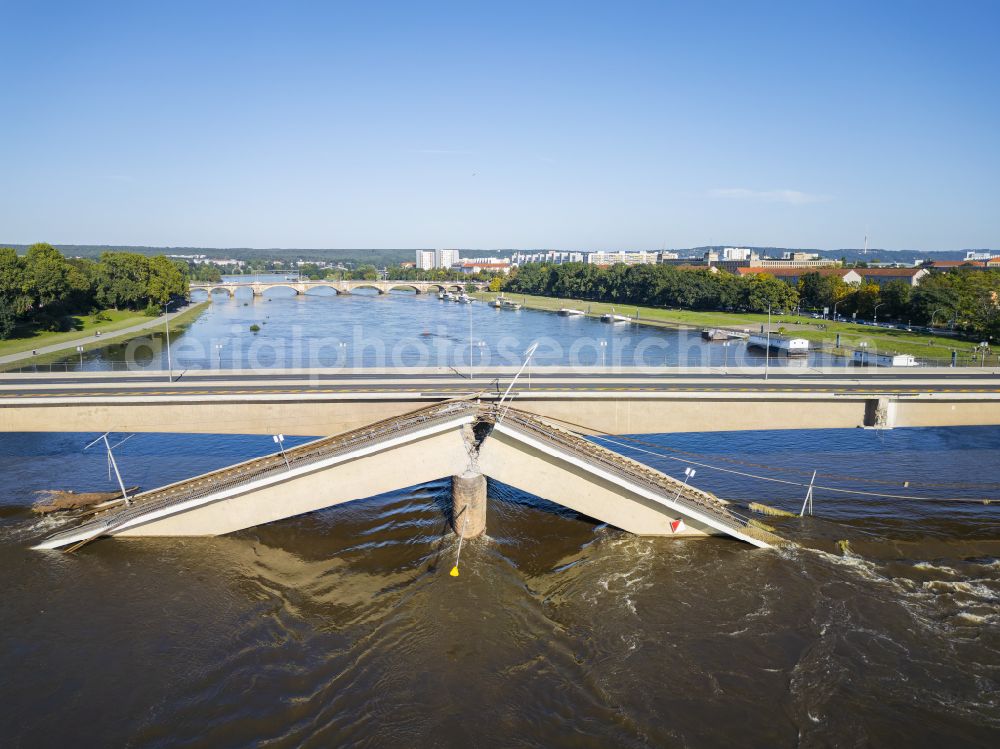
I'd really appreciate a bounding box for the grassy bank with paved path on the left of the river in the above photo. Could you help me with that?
[0,300,210,369]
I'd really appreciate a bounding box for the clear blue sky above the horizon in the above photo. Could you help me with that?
[0,0,1000,250]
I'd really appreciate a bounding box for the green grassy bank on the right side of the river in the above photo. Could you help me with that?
[475,292,984,365]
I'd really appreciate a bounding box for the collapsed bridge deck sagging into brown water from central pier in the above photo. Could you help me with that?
[36,401,782,549]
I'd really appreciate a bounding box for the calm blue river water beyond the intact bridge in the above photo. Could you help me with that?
[48,277,848,370]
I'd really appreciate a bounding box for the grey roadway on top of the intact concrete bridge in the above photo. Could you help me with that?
[0,368,1000,399]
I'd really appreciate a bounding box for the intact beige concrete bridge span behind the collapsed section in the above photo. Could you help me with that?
[0,367,1000,436]
